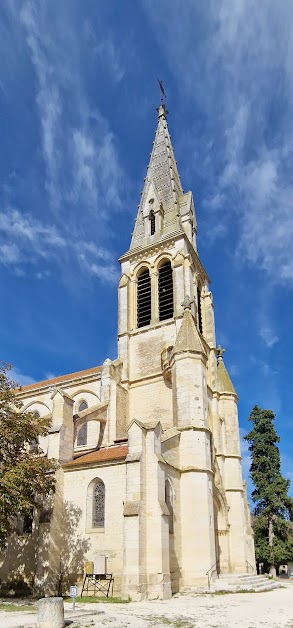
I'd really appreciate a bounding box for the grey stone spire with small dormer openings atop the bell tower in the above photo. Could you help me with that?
[130,104,195,249]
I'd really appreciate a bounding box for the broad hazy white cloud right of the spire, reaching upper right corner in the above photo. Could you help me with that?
[144,0,293,284]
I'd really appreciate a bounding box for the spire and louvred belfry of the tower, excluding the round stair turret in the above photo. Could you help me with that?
[118,104,216,429]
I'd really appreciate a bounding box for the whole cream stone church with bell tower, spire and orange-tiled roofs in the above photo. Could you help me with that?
[0,104,255,600]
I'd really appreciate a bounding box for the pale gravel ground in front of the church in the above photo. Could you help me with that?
[0,583,293,628]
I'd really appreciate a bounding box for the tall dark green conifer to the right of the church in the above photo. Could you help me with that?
[244,406,293,573]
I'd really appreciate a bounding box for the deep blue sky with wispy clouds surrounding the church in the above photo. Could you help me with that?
[0,0,293,494]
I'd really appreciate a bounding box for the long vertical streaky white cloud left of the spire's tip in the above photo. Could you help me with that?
[20,0,123,217]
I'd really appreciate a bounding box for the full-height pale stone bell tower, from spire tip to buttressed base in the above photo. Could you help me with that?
[118,104,253,599]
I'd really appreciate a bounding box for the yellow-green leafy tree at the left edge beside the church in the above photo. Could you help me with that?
[0,363,56,547]
